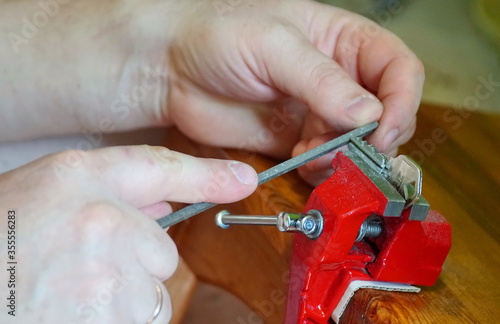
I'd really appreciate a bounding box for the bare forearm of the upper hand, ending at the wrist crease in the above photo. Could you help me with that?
[0,0,184,141]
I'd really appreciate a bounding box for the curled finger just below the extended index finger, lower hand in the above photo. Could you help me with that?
[72,202,178,280]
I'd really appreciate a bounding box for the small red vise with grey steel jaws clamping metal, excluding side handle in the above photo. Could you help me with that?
[285,138,451,324]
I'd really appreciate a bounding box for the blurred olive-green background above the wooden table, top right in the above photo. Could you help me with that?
[321,0,500,112]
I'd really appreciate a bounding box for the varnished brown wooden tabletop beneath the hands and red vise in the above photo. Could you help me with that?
[168,105,500,324]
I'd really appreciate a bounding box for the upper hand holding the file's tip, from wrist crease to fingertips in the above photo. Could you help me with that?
[166,0,424,184]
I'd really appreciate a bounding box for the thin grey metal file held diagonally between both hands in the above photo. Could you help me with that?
[156,122,378,228]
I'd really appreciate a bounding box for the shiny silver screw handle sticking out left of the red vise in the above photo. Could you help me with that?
[215,209,324,240]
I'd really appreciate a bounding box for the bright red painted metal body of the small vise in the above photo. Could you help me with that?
[285,153,451,324]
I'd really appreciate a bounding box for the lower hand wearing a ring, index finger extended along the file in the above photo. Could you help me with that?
[0,146,257,324]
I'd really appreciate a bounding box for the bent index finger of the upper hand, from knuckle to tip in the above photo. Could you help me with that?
[308,2,424,152]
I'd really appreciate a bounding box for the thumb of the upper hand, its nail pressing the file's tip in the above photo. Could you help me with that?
[263,32,383,131]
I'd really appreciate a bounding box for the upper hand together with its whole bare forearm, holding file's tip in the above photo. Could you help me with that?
[0,0,424,183]
